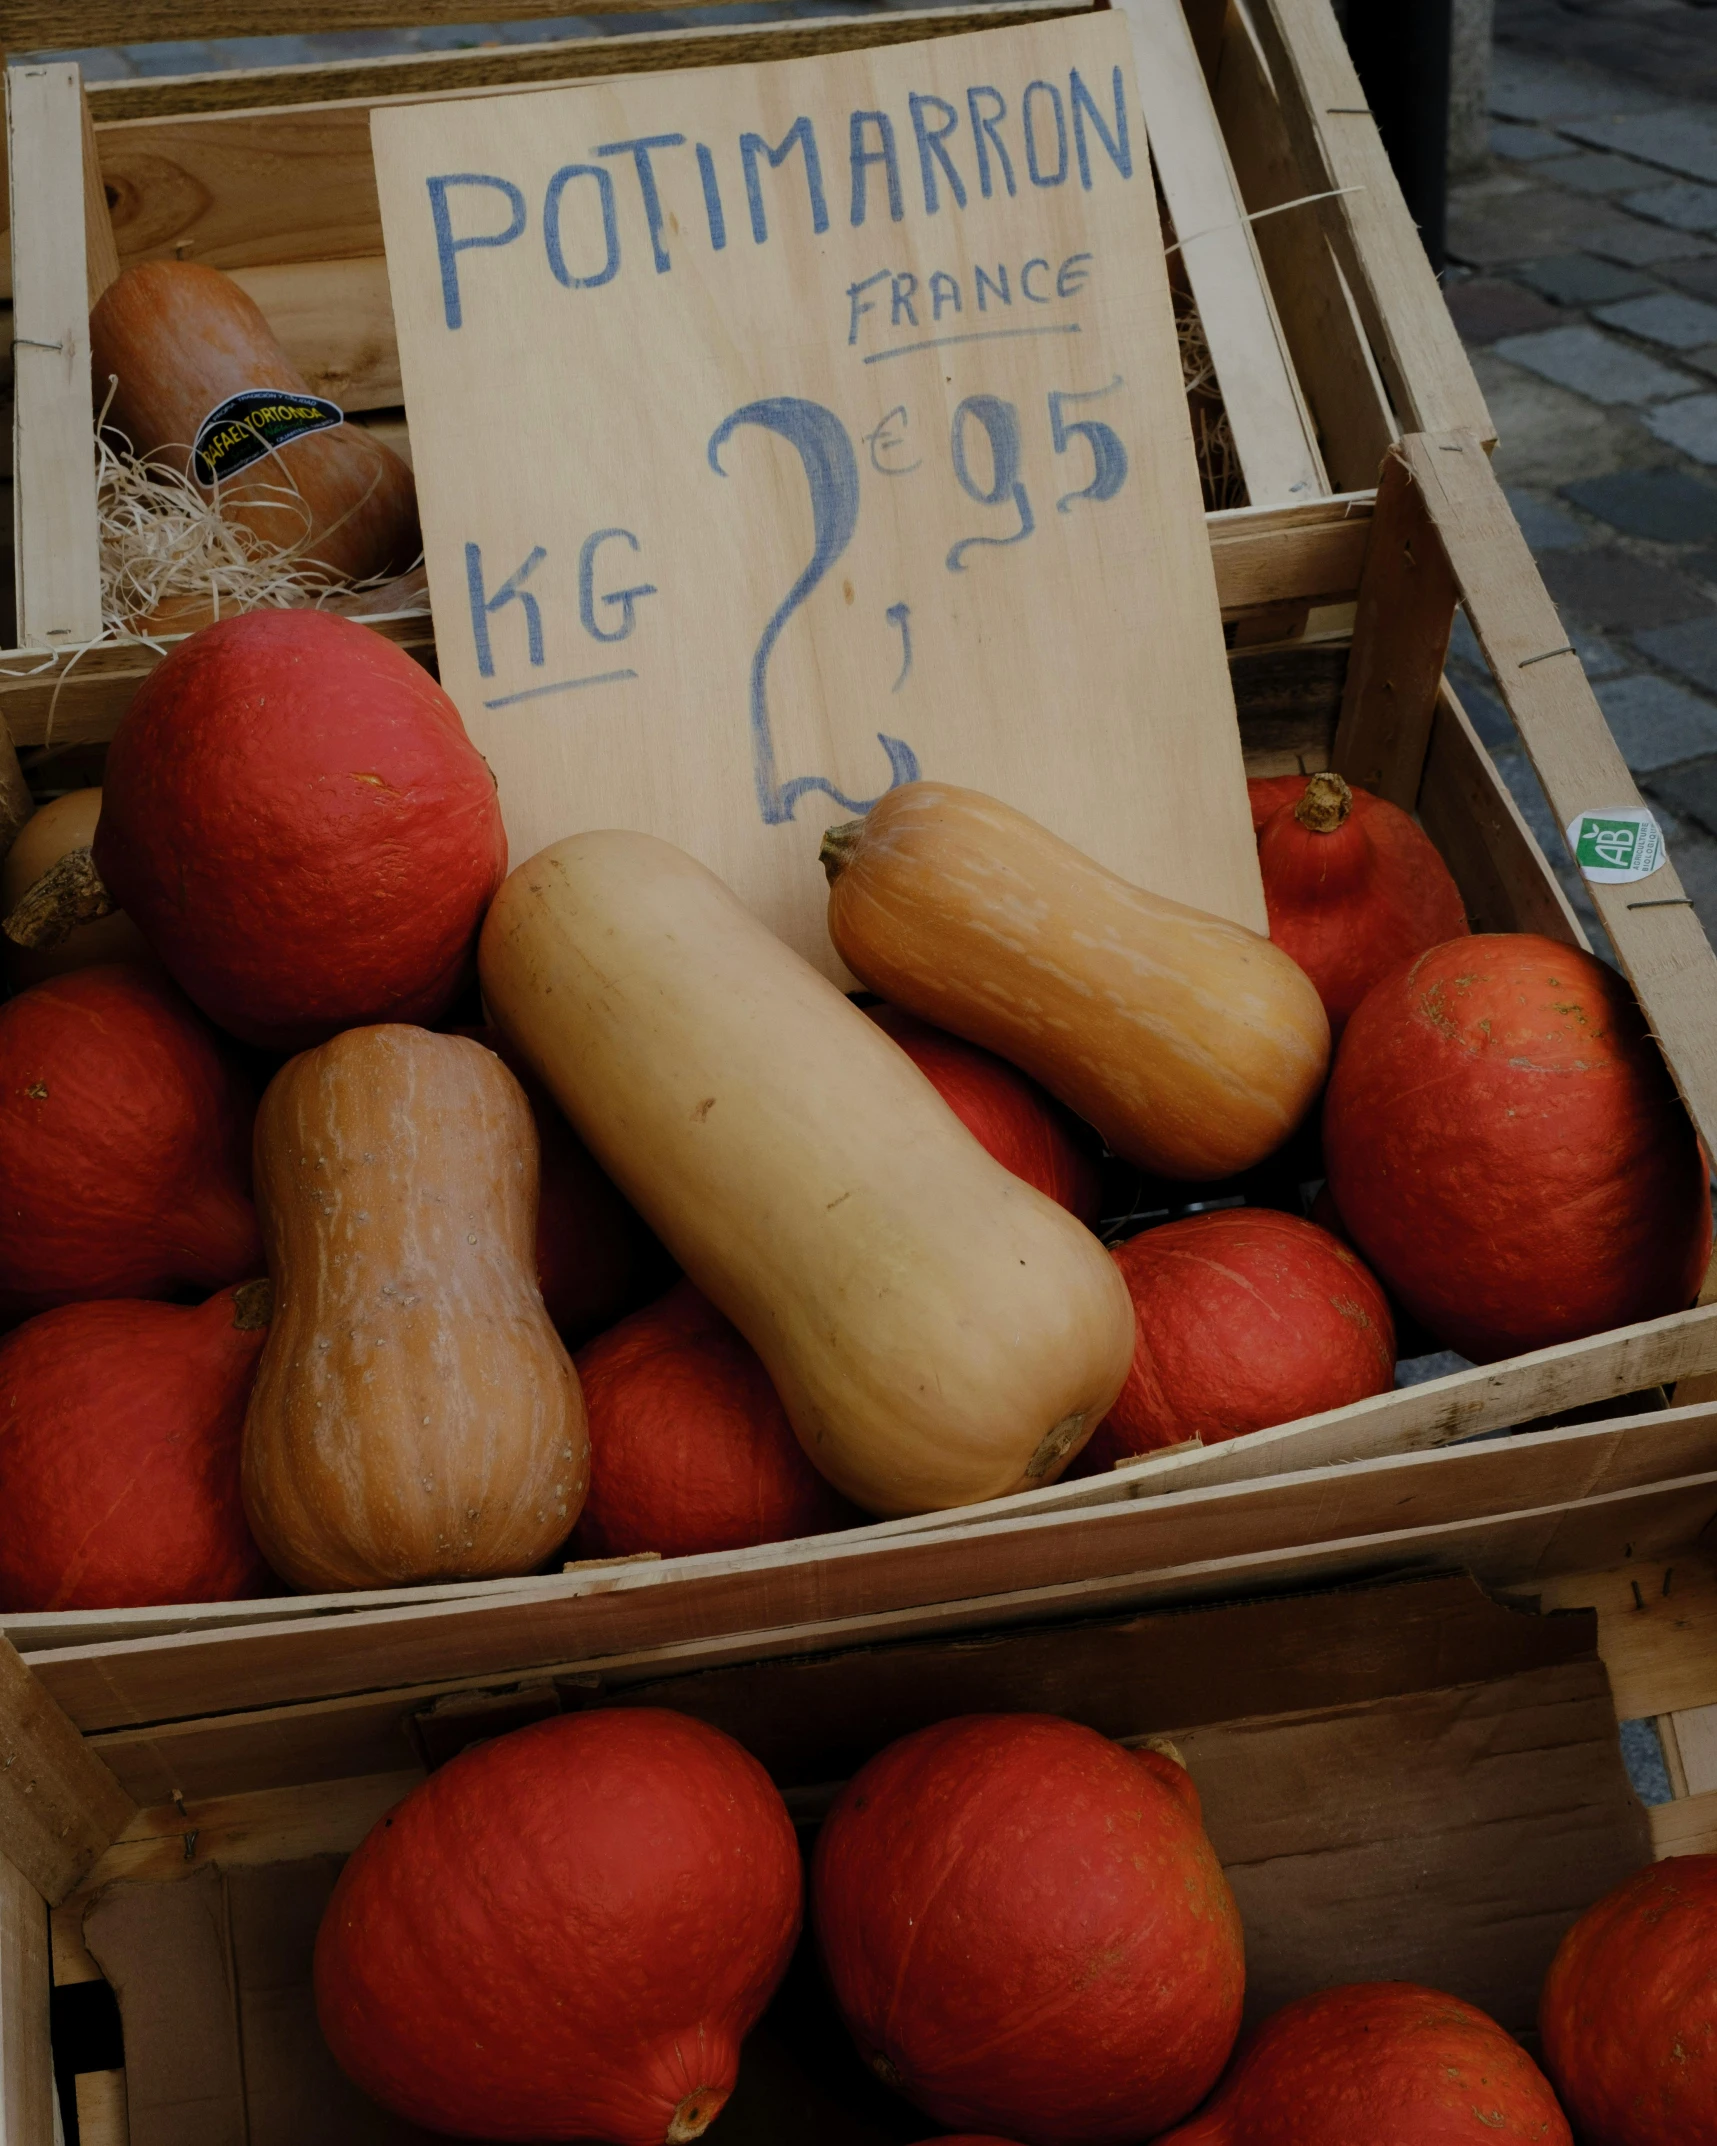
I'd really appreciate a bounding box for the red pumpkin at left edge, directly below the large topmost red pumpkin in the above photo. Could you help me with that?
[0,968,262,1311]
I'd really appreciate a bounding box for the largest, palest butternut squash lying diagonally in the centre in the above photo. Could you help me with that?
[479,833,1133,1515]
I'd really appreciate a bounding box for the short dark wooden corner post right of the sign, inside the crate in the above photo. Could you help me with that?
[1335,451,1455,811]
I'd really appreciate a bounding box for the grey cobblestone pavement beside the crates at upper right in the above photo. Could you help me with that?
[1447,0,1717,938]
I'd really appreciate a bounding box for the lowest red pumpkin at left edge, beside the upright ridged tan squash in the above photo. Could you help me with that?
[0,1281,277,1610]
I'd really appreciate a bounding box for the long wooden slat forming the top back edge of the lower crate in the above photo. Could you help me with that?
[32,1408,1717,1732]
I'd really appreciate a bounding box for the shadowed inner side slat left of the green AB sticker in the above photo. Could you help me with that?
[1419,678,1588,952]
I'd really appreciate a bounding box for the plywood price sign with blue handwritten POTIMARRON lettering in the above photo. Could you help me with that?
[373,15,1264,974]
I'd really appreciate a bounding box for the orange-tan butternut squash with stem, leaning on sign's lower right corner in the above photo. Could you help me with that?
[822,783,1329,1178]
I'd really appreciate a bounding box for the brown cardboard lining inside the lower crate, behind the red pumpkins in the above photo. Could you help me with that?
[52,1549,1674,2146]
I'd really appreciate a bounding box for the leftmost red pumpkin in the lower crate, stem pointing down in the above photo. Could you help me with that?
[315,1706,801,2146]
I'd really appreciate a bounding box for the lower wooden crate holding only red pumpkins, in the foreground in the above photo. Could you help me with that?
[0,1527,1717,2146]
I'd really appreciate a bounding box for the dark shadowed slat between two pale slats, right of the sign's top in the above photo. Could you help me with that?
[1204,9,1399,491]
